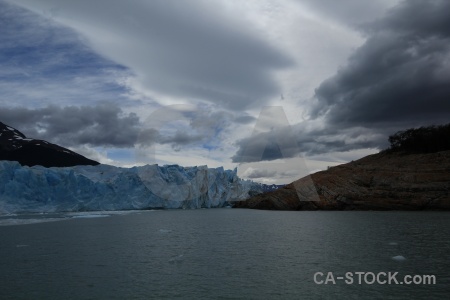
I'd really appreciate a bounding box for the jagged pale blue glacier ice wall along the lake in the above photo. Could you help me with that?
[0,161,263,214]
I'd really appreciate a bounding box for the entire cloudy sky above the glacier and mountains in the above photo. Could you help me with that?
[0,0,450,184]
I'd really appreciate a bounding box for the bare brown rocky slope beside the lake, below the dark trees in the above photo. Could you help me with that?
[234,151,450,210]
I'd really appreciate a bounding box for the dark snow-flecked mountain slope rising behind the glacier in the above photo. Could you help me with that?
[0,122,99,168]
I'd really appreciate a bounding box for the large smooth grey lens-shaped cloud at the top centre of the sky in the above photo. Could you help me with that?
[11,0,294,110]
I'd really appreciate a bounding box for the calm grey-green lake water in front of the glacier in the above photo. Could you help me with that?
[0,209,450,299]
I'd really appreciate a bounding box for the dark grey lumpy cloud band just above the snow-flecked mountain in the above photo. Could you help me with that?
[0,103,140,147]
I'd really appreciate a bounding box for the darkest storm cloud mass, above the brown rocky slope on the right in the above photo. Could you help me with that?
[232,0,450,162]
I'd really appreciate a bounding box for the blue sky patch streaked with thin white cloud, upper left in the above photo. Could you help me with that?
[0,1,128,107]
